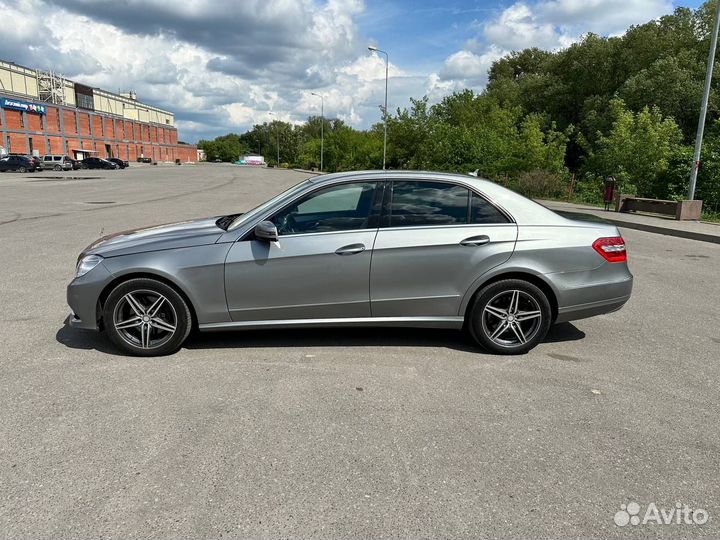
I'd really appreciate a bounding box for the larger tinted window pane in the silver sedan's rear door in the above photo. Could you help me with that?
[390,182,470,227]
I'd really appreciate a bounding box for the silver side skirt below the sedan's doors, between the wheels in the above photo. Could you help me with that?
[198,317,463,332]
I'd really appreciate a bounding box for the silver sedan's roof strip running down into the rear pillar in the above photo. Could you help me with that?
[310,170,568,225]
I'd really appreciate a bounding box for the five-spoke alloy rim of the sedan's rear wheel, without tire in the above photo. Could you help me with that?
[482,289,542,347]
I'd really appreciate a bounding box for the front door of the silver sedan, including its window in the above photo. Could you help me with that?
[225,182,382,321]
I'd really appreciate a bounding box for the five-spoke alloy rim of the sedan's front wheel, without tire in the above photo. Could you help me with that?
[113,289,178,349]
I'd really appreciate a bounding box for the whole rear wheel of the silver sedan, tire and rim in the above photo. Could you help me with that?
[468,279,552,354]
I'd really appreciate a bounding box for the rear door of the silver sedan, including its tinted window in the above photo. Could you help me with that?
[370,179,517,317]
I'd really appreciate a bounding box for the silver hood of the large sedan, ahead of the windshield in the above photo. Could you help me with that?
[81,217,225,257]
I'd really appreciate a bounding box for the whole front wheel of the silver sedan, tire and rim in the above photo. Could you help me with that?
[103,278,192,356]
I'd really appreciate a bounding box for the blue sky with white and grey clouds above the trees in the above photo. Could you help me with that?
[0,0,701,142]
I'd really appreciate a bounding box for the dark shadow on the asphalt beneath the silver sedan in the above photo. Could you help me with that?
[55,323,585,355]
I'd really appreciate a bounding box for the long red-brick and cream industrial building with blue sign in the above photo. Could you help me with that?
[0,61,197,163]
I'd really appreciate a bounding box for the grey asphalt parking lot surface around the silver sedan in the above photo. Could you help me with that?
[0,165,720,538]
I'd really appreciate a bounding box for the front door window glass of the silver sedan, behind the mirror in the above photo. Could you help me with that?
[271,182,377,236]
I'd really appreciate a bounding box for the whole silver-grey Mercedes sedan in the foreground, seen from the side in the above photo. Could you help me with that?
[67,171,633,356]
